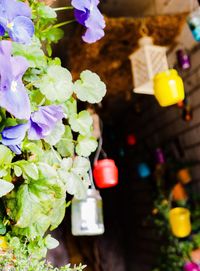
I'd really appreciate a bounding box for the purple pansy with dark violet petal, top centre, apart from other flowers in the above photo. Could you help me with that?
[71,0,105,43]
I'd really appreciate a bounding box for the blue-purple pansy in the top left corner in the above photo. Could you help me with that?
[0,0,34,44]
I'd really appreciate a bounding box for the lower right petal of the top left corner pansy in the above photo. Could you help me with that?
[8,16,34,44]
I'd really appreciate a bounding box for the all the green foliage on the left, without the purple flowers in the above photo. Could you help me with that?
[0,0,106,271]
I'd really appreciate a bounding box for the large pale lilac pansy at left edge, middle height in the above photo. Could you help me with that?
[0,41,31,119]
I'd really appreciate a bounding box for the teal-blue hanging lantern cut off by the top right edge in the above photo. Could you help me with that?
[187,4,200,41]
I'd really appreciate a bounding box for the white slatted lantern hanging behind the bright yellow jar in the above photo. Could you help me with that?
[129,36,168,94]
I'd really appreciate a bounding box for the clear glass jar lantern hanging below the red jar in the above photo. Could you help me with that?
[71,188,104,236]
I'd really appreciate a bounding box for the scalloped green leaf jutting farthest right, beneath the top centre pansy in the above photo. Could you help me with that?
[74,70,106,103]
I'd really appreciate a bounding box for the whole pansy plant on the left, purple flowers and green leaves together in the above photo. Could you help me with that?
[0,0,106,271]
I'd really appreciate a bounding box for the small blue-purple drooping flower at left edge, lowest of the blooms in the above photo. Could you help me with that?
[1,123,29,154]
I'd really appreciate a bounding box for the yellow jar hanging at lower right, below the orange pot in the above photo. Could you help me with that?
[169,207,191,238]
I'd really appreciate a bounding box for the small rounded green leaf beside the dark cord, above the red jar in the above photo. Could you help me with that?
[76,135,98,157]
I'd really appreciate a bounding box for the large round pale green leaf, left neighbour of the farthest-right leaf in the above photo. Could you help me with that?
[34,65,73,102]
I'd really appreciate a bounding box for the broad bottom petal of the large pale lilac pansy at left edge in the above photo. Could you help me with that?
[0,80,31,119]
